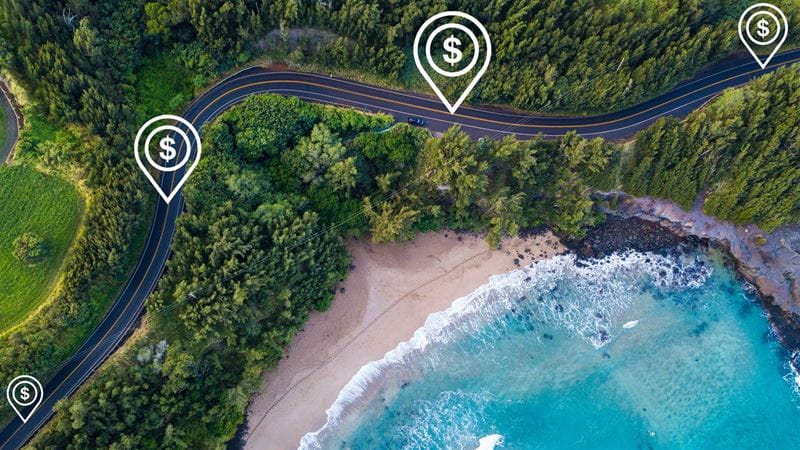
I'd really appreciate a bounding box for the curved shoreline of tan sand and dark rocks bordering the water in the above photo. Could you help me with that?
[242,205,800,448]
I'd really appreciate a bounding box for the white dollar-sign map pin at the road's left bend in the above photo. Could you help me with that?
[133,114,202,203]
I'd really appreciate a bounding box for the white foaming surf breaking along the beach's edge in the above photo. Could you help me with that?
[300,252,712,449]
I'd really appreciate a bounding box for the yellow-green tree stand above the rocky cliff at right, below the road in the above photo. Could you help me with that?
[619,65,800,231]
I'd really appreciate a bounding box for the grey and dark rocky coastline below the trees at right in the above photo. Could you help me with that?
[580,192,800,377]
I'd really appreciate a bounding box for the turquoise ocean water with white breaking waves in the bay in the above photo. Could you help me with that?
[302,251,800,449]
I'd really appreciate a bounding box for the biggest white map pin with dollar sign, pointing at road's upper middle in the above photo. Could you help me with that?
[414,11,492,114]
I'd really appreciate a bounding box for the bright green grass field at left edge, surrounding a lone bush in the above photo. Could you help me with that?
[0,166,83,332]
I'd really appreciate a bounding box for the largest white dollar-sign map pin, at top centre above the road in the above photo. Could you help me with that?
[414,11,492,114]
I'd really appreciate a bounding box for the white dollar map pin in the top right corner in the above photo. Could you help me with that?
[739,3,789,69]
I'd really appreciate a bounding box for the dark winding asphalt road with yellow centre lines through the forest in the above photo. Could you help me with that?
[0,50,800,449]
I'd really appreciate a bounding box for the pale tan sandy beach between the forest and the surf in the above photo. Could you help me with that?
[246,232,564,449]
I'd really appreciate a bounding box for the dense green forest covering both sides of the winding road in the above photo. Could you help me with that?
[0,0,800,448]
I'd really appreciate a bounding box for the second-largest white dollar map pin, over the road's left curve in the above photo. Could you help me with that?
[133,114,202,203]
